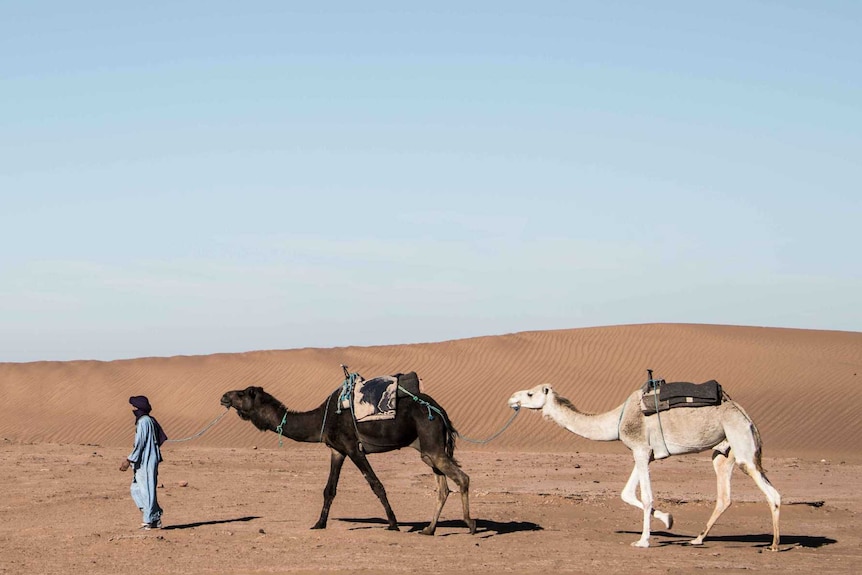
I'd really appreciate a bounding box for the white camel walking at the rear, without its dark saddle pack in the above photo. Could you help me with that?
[509,384,781,551]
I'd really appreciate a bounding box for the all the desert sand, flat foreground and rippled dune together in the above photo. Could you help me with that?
[0,324,862,574]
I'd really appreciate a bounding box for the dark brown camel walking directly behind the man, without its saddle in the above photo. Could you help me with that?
[221,387,476,535]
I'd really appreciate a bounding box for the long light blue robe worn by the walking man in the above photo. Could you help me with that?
[127,415,162,523]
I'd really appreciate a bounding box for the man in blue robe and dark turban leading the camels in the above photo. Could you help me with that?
[120,395,168,529]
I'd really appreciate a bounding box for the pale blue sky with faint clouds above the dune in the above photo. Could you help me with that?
[0,0,862,362]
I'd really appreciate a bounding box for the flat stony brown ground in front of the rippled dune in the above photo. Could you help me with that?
[0,440,862,575]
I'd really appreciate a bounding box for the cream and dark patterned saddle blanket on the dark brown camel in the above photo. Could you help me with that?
[341,371,420,422]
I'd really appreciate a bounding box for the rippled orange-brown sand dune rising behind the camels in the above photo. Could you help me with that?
[0,324,862,456]
